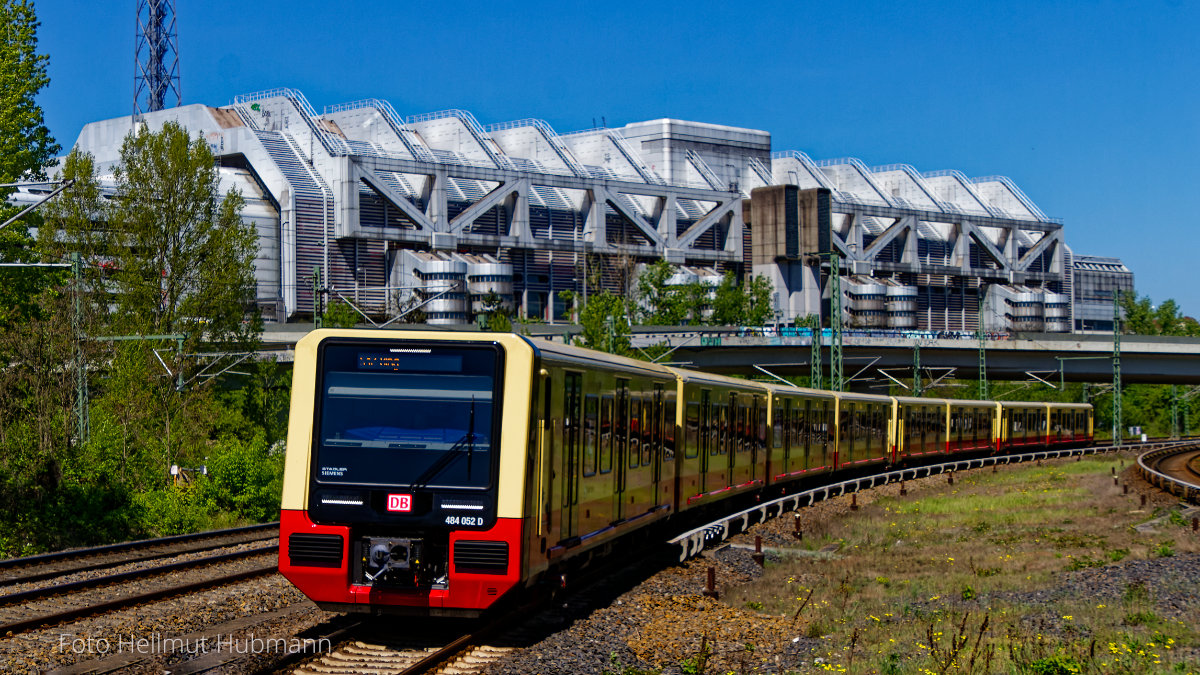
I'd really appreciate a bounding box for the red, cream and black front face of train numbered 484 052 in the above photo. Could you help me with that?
[280,330,533,617]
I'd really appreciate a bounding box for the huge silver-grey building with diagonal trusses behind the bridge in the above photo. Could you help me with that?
[30,89,1123,330]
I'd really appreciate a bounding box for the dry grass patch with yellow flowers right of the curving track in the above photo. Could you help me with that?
[724,458,1200,675]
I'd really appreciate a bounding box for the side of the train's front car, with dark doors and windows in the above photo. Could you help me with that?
[529,341,676,578]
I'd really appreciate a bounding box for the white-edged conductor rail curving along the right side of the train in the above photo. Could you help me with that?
[668,441,1195,562]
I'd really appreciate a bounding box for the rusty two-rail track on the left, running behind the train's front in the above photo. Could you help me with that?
[0,542,278,635]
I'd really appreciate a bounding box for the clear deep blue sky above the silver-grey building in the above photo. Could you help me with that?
[37,0,1200,316]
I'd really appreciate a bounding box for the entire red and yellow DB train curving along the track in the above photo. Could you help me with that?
[280,329,1092,616]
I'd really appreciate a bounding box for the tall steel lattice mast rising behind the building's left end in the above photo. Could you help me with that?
[133,0,184,120]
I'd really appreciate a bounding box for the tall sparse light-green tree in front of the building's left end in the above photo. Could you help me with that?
[103,121,258,347]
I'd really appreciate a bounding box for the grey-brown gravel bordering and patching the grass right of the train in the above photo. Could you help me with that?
[477,451,1200,675]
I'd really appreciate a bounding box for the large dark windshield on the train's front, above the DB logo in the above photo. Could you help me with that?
[314,345,499,489]
